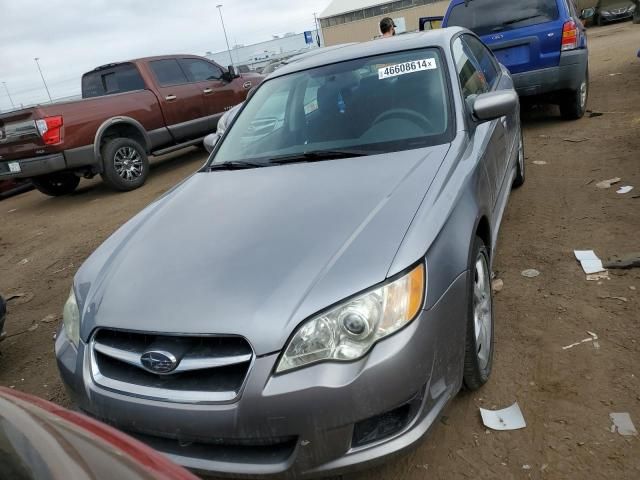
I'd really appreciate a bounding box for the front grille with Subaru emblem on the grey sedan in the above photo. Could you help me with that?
[90,329,253,403]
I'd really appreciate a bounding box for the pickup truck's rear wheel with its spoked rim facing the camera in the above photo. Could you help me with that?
[100,138,149,192]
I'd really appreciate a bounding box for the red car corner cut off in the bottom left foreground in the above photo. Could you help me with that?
[0,387,197,480]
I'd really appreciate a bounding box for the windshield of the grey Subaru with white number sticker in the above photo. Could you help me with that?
[213,49,451,164]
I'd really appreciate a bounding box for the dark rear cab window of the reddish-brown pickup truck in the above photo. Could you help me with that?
[82,63,145,98]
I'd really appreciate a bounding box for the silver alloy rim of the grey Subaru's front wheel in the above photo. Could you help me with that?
[473,254,493,370]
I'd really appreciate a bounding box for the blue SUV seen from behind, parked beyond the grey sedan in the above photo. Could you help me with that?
[443,0,589,120]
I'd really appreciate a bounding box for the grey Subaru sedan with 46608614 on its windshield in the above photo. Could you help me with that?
[55,28,525,478]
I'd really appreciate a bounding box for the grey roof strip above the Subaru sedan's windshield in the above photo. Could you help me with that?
[271,27,467,78]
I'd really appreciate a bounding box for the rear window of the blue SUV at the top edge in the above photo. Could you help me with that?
[447,0,560,35]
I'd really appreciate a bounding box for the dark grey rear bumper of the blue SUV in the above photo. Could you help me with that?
[512,49,589,97]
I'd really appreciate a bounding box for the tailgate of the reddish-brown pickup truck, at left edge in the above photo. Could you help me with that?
[0,108,45,161]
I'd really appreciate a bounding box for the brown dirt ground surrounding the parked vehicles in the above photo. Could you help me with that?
[0,23,640,480]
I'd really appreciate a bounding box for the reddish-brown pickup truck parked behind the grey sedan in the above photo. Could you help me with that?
[0,55,264,196]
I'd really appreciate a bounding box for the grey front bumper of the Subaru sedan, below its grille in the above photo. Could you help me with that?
[56,273,467,478]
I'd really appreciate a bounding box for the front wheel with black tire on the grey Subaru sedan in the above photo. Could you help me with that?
[463,237,494,391]
